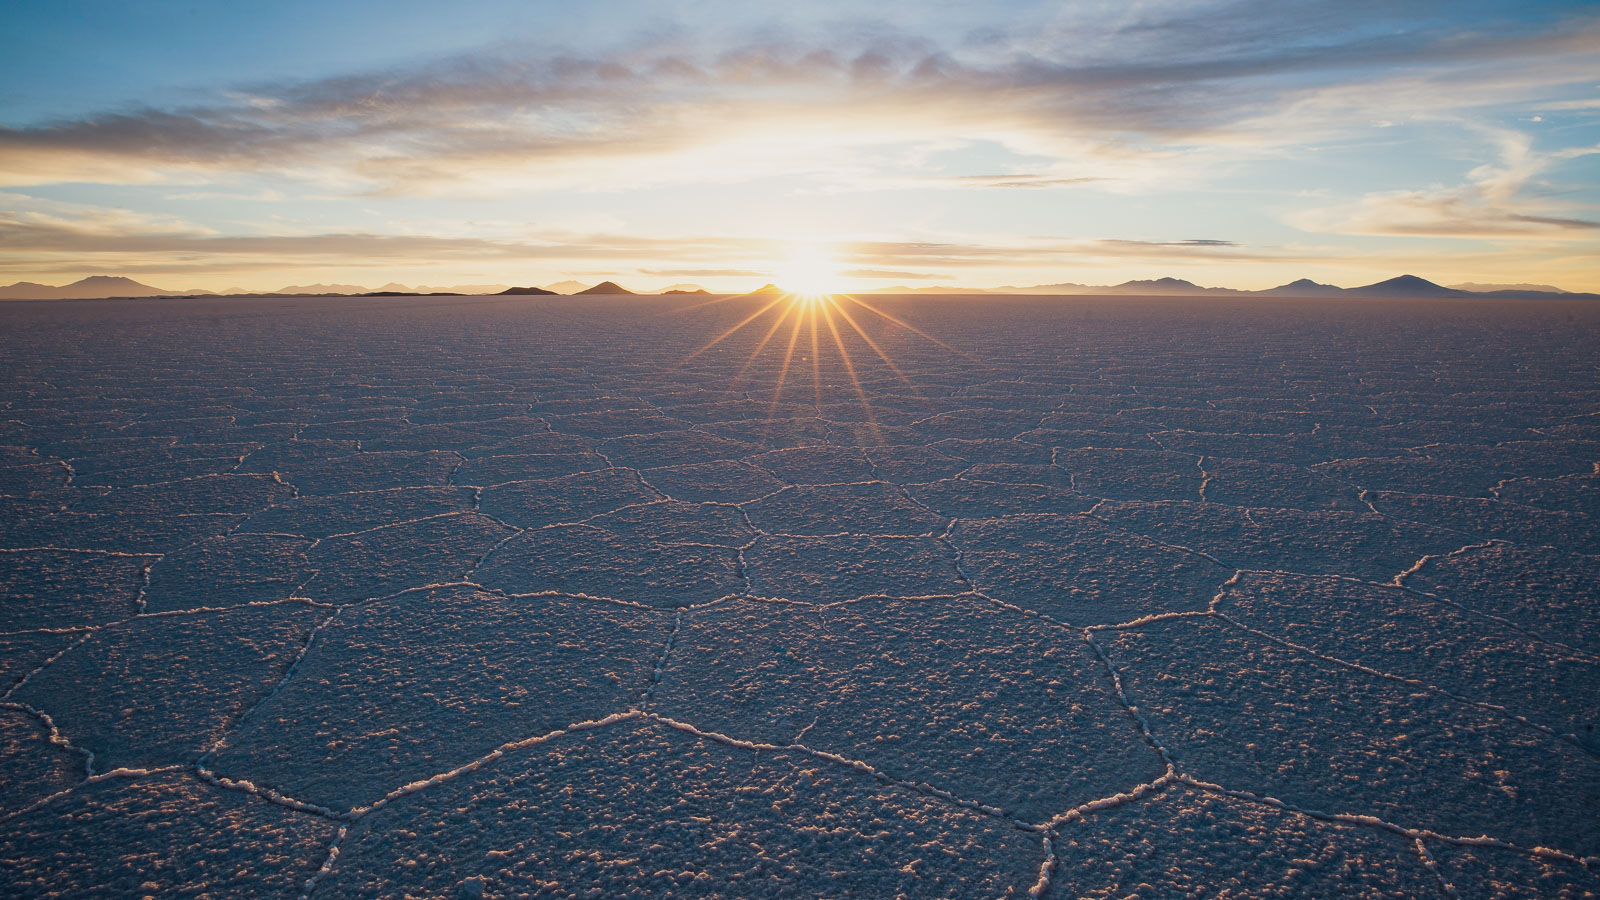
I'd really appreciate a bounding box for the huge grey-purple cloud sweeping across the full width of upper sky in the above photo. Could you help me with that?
[0,3,1600,194]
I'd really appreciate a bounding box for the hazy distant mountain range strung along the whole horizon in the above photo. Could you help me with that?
[0,275,1600,299]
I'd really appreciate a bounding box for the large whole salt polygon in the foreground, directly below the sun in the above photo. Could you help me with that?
[653,597,1162,822]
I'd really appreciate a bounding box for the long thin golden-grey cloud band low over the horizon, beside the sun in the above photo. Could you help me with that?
[0,194,1318,280]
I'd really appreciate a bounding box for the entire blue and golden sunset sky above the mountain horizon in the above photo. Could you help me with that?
[0,0,1600,291]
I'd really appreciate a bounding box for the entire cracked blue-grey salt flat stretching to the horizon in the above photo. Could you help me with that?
[0,296,1600,898]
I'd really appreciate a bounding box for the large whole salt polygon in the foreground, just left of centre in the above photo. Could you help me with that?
[208,586,670,809]
